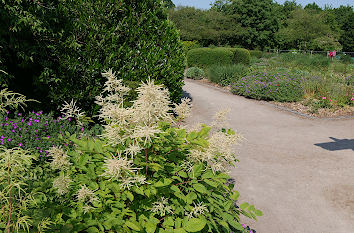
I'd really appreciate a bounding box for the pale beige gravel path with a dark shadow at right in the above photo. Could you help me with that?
[184,80,354,233]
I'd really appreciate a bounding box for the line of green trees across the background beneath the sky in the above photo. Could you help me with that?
[166,0,354,51]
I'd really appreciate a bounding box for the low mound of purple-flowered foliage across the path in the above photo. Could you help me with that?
[231,72,304,102]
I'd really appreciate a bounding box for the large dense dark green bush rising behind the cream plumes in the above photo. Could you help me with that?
[0,0,184,115]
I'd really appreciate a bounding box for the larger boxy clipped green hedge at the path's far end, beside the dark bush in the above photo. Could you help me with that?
[187,48,233,68]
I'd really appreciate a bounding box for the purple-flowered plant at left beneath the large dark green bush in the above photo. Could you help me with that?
[0,111,100,157]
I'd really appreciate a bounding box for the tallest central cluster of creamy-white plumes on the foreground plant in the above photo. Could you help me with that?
[96,69,173,150]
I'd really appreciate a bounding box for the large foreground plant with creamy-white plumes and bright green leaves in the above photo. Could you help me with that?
[31,70,262,233]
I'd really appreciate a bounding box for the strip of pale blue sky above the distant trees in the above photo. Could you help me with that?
[172,0,354,9]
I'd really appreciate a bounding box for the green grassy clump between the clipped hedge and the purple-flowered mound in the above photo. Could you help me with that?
[208,64,248,86]
